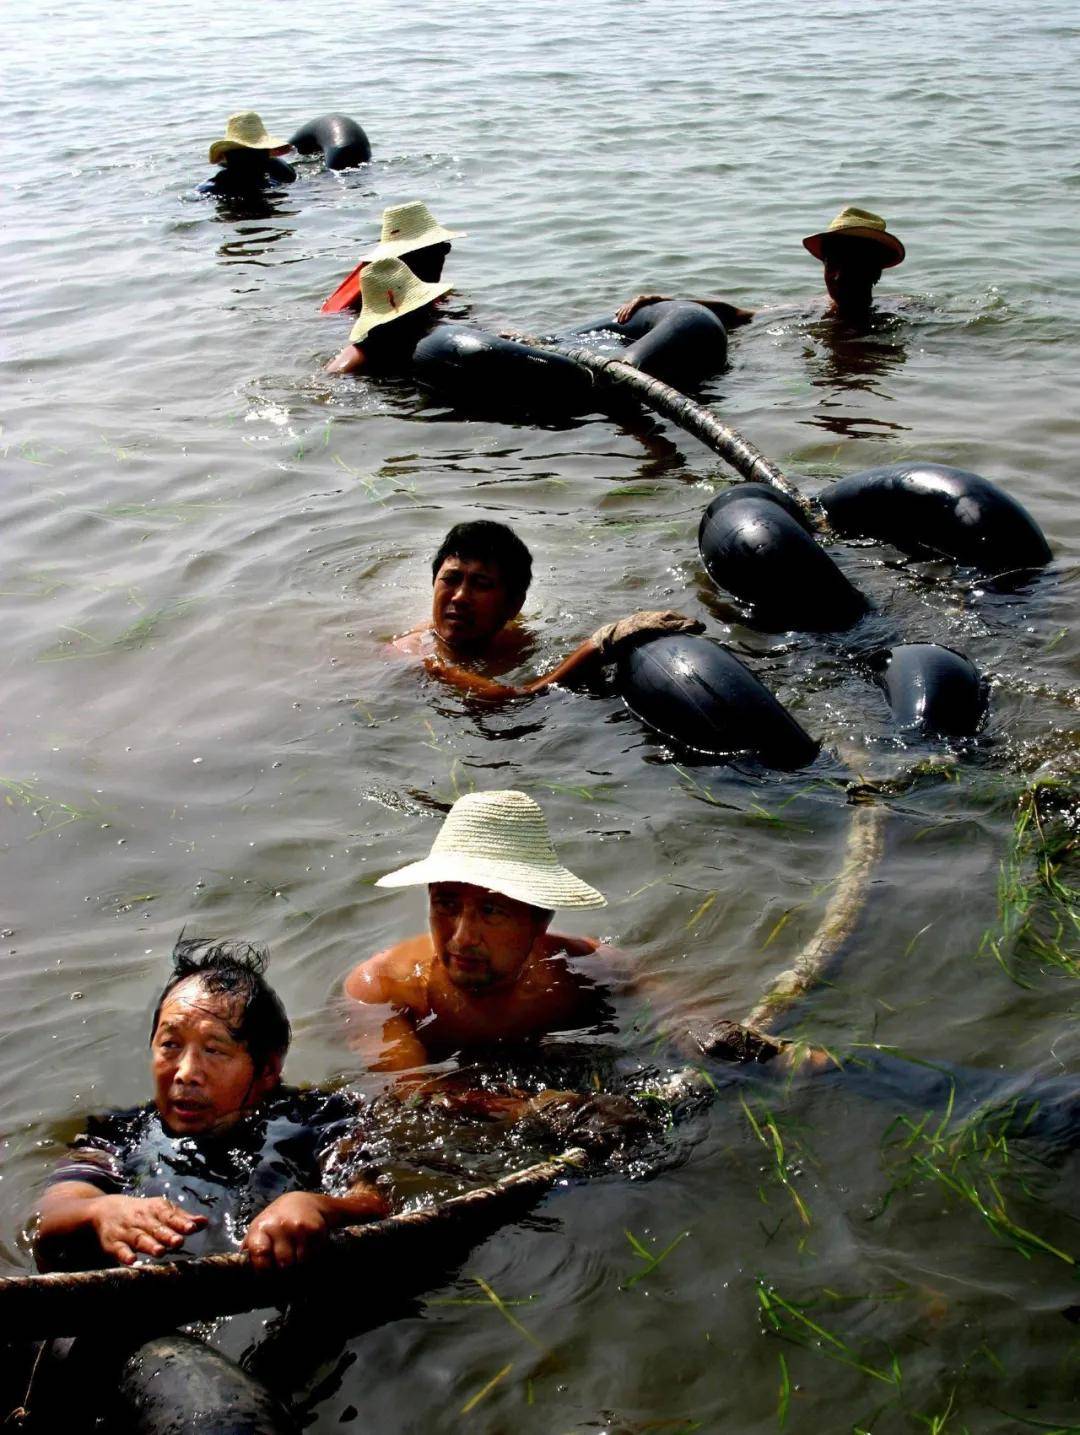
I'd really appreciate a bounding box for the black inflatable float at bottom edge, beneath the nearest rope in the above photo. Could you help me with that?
[119,1335,298,1435]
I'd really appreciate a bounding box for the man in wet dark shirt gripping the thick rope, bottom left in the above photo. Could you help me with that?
[36,937,387,1269]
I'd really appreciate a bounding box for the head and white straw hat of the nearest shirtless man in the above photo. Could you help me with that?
[376,792,607,994]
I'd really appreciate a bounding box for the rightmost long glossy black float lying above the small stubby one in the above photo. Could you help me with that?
[820,464,1051,574]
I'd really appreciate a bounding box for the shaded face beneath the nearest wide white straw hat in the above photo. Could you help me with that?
[427,883,551,993]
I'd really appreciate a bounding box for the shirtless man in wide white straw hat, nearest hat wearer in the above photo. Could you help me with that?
[346,792,607,1071]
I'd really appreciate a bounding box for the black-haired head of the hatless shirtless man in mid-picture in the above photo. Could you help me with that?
[432,518,532,651]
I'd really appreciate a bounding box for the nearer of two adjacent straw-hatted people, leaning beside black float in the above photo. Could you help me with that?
[326,258,452,373]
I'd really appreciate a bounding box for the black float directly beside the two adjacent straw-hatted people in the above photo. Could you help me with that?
[413,321,597,416]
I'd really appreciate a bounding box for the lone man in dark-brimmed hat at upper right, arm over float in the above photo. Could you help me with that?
[615,205,905,329]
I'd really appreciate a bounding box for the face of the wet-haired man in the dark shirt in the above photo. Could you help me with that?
[151,976,281,1137]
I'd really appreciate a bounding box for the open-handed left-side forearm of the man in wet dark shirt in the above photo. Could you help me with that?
[34,1181,207,1270]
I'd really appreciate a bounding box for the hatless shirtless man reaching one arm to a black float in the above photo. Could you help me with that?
[392,519,703,697]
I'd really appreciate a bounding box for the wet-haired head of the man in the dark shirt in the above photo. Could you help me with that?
[151,937,291,1135]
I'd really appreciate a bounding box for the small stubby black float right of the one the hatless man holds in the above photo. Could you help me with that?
[871,643,987,738]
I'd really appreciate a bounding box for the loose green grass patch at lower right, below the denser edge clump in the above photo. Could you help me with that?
[876,1088,1077,1266]
